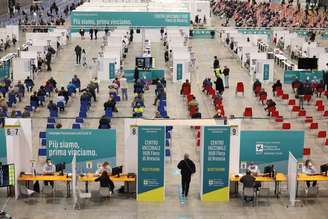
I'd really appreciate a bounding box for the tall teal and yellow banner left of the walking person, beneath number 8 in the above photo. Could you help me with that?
[137,126,165,201]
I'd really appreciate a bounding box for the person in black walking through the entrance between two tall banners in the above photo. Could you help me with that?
[178,154,196,197]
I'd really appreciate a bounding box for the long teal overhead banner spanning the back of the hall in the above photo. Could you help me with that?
[71,11,190,32]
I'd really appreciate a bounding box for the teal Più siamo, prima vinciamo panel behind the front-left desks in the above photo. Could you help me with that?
[46,129,116,172]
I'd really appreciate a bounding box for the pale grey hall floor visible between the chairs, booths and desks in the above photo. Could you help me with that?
[0,16,328,219]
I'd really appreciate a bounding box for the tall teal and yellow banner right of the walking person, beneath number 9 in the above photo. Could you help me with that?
[201,126,230,201]
